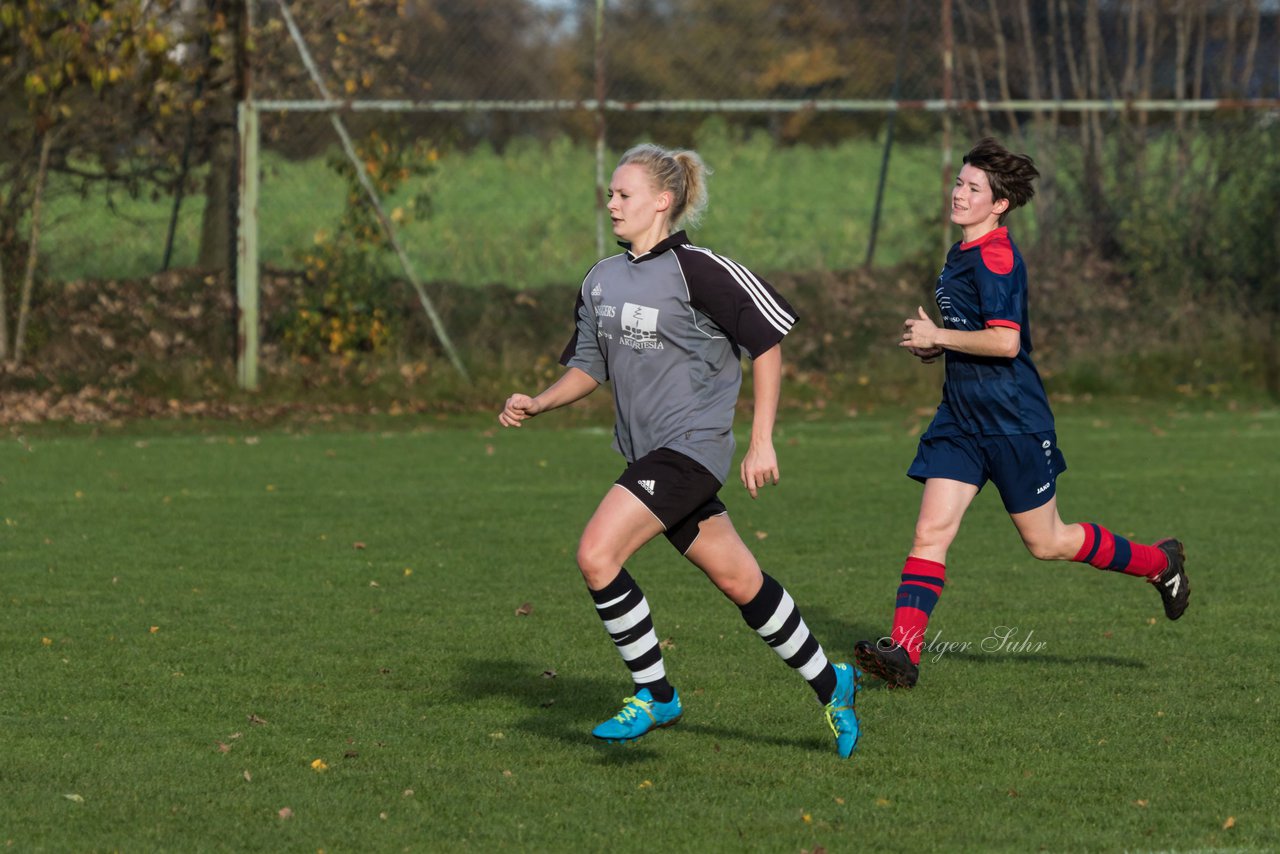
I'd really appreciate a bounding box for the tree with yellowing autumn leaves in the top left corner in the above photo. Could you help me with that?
[0,0,198,363]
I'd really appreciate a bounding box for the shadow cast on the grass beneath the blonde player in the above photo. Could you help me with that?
[453,659,832,763]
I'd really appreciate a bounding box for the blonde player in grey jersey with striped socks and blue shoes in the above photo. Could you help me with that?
[498,145,859,757]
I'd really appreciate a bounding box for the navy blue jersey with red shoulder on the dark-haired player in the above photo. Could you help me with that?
[928,228,1053,437]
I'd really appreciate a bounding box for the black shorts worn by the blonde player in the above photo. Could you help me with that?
[614,448,728,554]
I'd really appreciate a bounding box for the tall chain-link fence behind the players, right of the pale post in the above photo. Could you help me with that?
[225,0,1280,386]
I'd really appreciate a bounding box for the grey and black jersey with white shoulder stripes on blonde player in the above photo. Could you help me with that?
[561,232,796,483]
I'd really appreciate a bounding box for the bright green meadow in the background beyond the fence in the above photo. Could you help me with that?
[41,133,941,288]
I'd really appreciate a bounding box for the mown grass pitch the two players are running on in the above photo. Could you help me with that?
[0,405,1280,851]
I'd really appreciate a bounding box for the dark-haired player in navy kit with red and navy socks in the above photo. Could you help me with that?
[854,138,1190,688]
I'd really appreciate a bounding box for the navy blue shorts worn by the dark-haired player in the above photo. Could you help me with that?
[906,430,1066,513]
